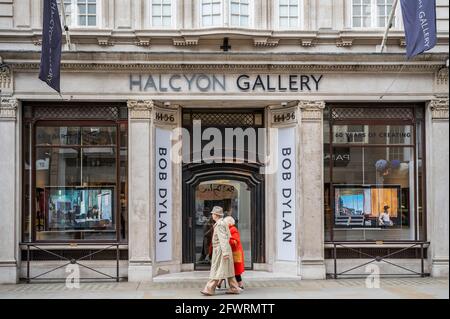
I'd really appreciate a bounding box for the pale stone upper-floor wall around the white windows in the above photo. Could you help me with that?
[0,0,449,54]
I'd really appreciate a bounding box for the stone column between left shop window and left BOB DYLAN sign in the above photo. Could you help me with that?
[128,100,154,282]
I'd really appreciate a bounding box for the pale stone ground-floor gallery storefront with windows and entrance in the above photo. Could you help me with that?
[0,53,448,281]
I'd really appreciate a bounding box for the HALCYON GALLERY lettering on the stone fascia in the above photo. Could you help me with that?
[129,73,323,93]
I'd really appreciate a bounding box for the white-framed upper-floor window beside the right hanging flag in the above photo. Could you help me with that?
[351,0,399,28]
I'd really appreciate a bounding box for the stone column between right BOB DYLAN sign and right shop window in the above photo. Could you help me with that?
[298,101,325,279]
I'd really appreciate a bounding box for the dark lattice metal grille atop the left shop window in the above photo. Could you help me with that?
[24,104,127,120]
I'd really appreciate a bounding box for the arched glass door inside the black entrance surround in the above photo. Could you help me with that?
[193,179,252,270]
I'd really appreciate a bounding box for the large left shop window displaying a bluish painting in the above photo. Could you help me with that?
[23,105,128,241]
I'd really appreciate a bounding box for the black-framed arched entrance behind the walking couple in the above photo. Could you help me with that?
[183,163,265,270]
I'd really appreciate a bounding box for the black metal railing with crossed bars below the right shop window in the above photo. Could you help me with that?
[327,241,430,279]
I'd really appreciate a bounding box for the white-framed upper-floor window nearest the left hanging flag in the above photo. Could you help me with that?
[58,0,100,27]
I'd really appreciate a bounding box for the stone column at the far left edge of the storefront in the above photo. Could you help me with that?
[0,96,20,284]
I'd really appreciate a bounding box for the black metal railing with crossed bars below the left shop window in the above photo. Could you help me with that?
[20,243,120,283]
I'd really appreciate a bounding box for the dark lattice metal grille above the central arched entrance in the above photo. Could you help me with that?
[191,112,262,127]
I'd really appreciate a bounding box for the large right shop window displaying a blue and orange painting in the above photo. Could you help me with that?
[324,106,426,241]
